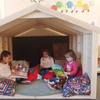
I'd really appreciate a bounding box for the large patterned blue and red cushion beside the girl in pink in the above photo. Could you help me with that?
[63,74,91,97]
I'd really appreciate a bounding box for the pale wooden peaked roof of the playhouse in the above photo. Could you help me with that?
[0,4,100,37]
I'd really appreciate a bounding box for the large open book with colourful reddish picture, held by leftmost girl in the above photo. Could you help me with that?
[10,61,29,78]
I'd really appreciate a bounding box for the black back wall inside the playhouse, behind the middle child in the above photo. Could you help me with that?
[12,36,69,67]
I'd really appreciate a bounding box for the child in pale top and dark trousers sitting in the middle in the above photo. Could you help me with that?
[39,49,54,78]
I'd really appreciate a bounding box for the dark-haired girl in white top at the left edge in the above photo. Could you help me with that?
[0,51,15,80]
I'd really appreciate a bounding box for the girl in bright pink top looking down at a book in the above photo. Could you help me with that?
[64,50,78,79]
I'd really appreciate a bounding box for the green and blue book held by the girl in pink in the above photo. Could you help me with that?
[51,64,67,77]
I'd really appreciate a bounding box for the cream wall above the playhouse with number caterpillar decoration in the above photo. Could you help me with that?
[0,0,100,57]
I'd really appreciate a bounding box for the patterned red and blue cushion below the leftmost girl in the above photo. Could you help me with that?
[0,78,16,96]
